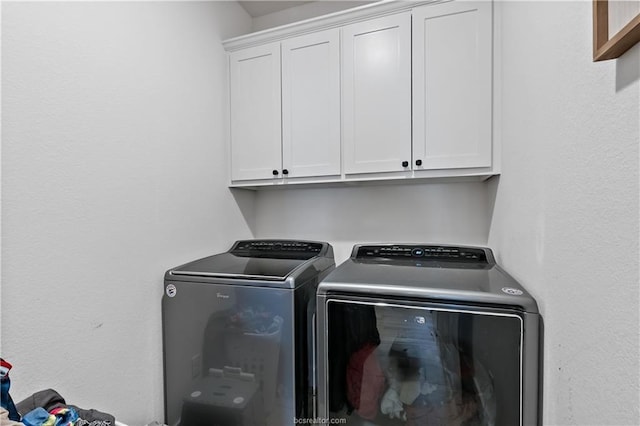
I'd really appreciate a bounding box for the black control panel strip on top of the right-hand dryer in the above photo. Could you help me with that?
[355,244,487,263]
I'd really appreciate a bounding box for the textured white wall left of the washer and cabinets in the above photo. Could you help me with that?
[1,2,252,426]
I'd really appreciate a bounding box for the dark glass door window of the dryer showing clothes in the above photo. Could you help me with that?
[325,300,522,426]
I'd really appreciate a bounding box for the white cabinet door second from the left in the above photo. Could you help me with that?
[282,29,340,177]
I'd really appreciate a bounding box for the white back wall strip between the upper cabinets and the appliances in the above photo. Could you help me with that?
[255,182,490,263]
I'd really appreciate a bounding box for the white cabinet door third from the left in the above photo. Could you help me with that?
[342,12,411,173]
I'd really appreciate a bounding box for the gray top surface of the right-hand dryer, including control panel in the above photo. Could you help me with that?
[318,244,538,313]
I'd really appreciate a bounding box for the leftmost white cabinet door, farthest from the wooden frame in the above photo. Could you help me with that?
[229,43,282,180]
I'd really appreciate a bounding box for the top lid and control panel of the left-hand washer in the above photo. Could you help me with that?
[170,240,327,281]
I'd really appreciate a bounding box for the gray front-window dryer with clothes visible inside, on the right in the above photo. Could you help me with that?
[317,244,543,426]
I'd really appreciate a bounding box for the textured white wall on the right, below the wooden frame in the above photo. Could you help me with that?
[489,1,640,426]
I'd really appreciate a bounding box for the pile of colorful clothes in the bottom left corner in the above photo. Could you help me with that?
[0,358,116,426]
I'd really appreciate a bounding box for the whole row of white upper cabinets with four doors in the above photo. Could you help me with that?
[223,0,500,187]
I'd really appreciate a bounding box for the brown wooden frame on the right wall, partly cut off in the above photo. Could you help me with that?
[593,0,640,62]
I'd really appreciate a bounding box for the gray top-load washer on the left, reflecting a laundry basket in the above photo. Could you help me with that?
[162,240,335,426]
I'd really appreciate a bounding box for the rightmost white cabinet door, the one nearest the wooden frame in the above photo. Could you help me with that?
[413,1,492,169]
